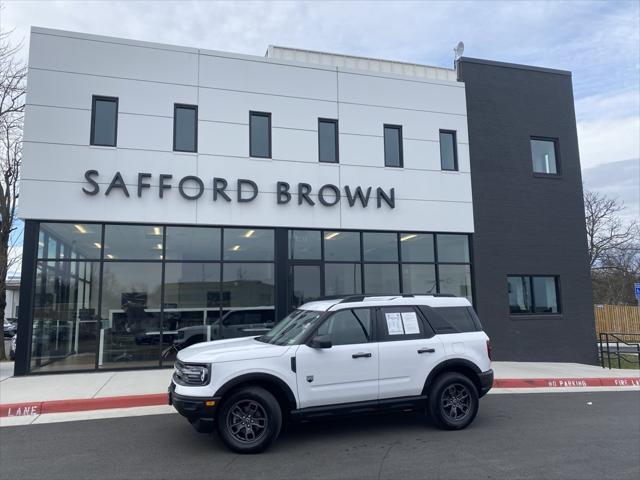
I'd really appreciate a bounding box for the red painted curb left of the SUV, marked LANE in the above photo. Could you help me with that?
[0,393,167,417]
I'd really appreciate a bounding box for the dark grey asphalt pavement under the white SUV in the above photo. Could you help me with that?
[0,392,640,480]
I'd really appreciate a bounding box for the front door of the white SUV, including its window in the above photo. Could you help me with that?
[296,308,378,408]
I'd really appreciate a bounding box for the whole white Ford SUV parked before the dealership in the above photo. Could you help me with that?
[169,295,493,453]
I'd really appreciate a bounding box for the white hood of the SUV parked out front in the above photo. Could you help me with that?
[172,337,290,363]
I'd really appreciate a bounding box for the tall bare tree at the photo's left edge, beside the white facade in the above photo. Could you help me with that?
[0,32,27,360]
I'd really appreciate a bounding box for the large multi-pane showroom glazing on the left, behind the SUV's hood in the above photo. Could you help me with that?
[31,223,275,372]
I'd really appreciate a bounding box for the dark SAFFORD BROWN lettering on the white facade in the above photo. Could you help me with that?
[82,170,396,208]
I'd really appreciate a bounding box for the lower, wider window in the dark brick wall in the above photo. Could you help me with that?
[507,275,560,314]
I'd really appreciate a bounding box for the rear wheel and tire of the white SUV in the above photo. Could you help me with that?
[427,372,479,430]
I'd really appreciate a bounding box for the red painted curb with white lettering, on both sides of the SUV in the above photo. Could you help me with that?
[0,377,640,417]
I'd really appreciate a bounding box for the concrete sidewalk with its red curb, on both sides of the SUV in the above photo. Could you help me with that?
[0,362,640,417]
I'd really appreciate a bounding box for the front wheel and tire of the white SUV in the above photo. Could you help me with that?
[216,387,282,453]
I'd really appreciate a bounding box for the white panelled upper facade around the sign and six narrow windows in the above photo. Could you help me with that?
[20,29,473,232]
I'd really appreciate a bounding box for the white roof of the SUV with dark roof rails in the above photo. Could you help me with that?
[298,295,471,312]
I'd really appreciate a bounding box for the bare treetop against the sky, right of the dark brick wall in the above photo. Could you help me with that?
[584,191,639,268]
